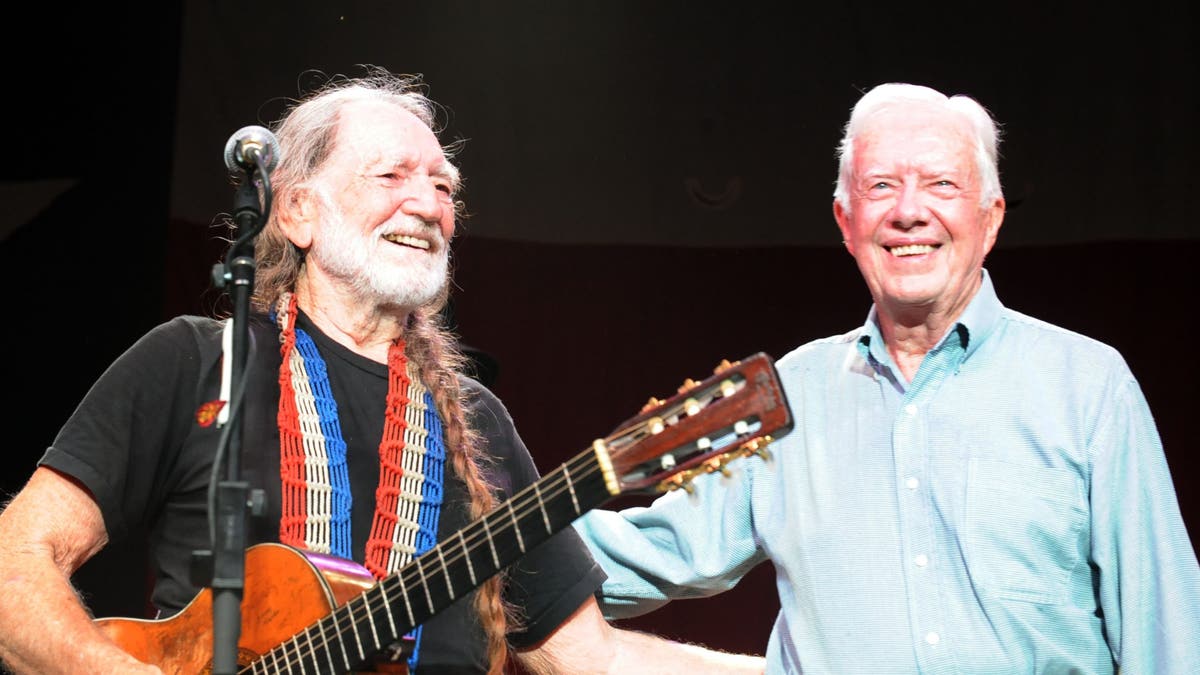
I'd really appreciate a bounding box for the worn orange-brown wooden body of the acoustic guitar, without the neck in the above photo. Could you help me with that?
[96,544,376,675]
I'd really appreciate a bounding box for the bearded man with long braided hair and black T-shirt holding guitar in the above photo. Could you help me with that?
[0,68,763,675]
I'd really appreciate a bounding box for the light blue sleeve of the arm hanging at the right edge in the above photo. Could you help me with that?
[1091,376,1200,673]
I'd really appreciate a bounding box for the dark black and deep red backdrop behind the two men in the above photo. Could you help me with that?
[0,0,1200,651]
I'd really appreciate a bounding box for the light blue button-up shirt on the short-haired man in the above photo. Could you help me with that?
[576,271,1200,675]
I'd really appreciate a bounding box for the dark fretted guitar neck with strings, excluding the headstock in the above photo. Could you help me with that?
[251,450,613,673]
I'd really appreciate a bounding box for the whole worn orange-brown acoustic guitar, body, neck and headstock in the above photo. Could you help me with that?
[96,352,793,675]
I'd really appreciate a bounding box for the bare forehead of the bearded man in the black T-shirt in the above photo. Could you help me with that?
[330,101,445,168]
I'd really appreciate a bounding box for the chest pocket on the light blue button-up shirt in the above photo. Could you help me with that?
[965,458,1087,603]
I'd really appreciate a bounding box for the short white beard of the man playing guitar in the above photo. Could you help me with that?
[308,195,450,310]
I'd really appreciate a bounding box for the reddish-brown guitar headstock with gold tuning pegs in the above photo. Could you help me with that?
[593,352,793,495]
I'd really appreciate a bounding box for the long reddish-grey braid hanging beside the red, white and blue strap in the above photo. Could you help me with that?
[404,307,517,675]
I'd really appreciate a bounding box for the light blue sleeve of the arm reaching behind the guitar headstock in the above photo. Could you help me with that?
[575,462,766,619]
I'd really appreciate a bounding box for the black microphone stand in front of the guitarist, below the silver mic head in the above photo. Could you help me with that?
[193,158,271,675]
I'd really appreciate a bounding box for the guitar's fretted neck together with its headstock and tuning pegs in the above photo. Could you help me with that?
[250,352,792,673]
